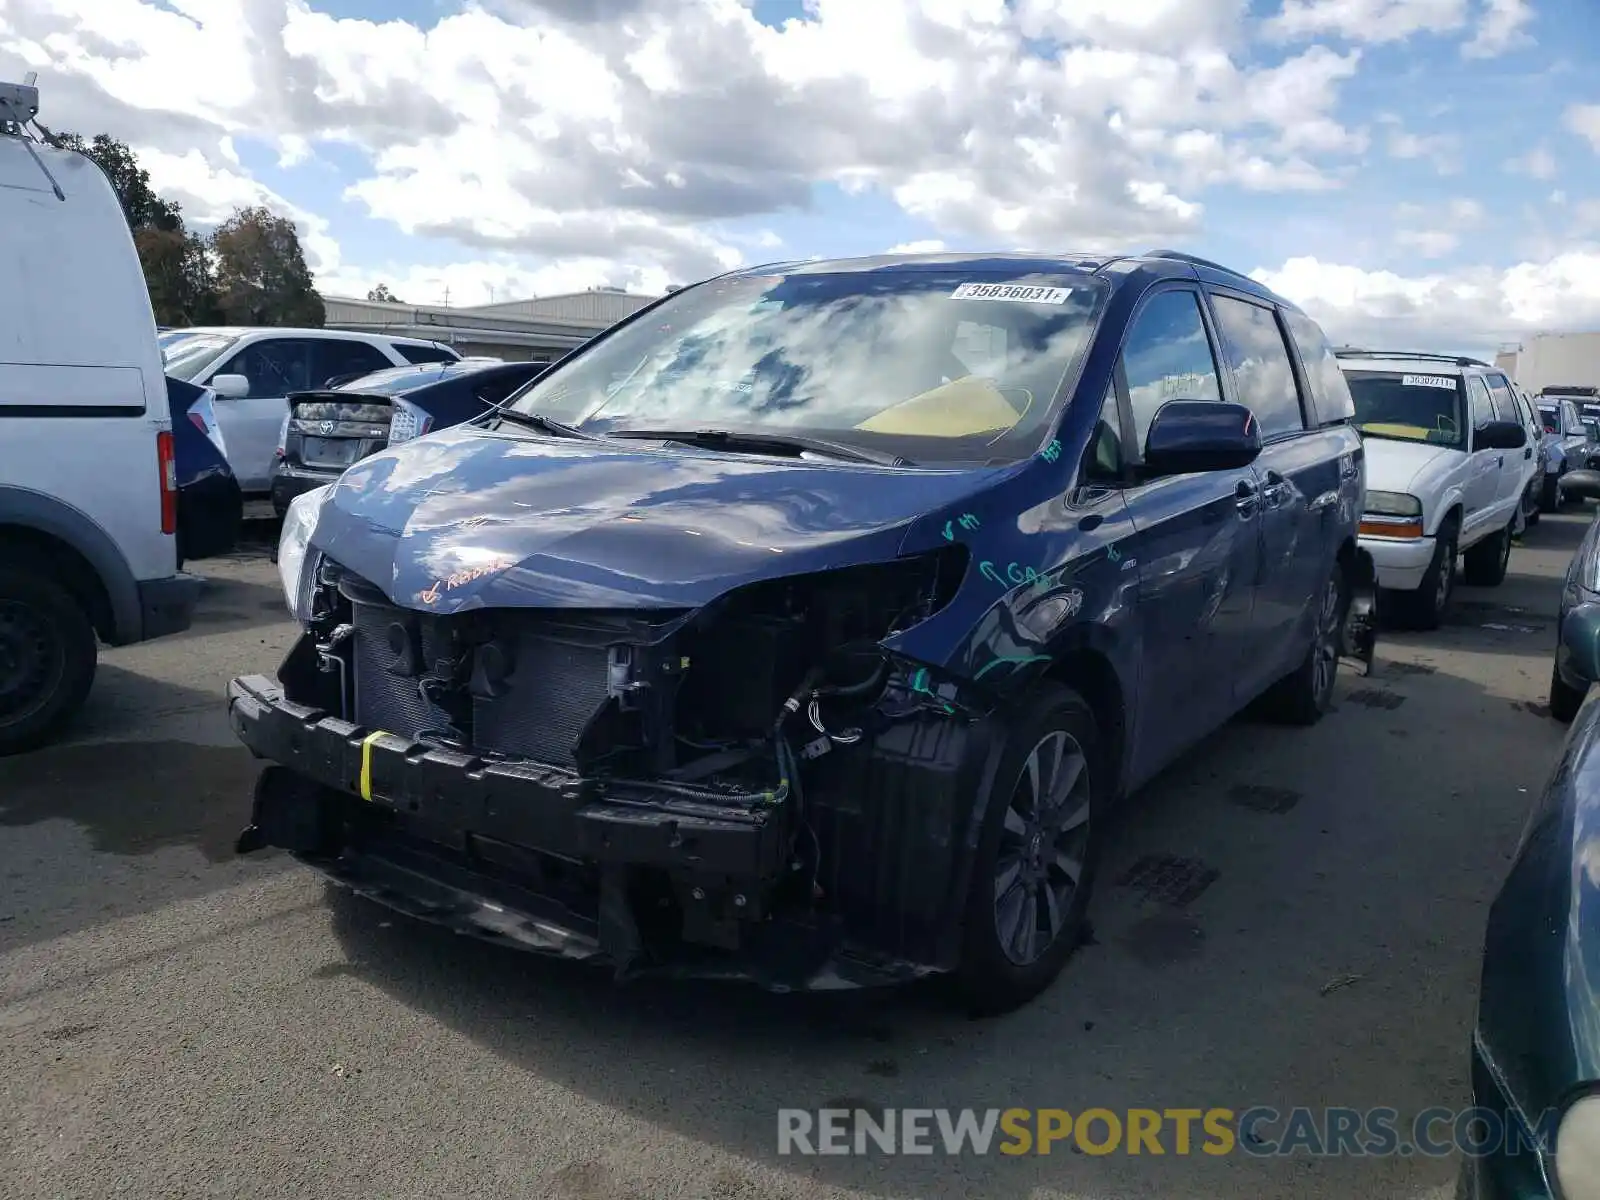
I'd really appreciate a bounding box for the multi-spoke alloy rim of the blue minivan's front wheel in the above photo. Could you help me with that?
[994,730,1090,966]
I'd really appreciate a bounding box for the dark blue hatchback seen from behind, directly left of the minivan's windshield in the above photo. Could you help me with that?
[272,358,544,517]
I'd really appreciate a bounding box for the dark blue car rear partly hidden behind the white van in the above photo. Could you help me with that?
[166,376,245,566]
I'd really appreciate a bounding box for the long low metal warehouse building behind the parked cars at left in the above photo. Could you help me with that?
[322,290,656,362]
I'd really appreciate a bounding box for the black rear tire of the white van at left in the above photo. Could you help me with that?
[0,568,99,757]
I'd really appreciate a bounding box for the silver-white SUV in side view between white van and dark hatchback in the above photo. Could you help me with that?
[162,326,461,496]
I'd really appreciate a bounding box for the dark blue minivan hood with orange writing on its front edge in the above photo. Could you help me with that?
[312,426,1016,613]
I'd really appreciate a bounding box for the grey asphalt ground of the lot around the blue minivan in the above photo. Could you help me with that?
[0,512,1589,1200]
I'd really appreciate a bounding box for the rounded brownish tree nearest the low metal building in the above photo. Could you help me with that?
[211,206,326,328]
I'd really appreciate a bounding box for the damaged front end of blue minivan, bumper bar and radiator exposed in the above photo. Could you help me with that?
[229,512,1003,990]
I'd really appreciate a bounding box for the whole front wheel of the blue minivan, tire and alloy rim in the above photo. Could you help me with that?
[957,683,1109,1016]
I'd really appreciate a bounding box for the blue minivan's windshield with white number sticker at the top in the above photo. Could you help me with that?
[510,267,1107,464]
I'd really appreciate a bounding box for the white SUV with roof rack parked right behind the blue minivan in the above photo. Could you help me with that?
[1338,350,1538,629]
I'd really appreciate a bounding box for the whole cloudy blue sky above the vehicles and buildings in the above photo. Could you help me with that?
[0,0,1600,354]
